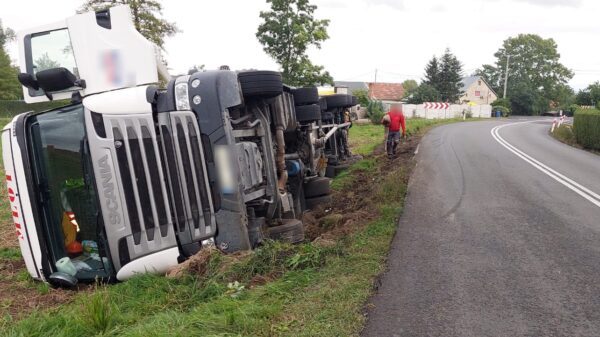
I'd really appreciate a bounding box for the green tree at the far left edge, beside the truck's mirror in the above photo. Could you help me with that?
[0,20,23,100]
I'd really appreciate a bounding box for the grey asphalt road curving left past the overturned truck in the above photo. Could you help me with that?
[363,119,600,337]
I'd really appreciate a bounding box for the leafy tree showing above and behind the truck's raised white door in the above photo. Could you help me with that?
[81,0,179,49]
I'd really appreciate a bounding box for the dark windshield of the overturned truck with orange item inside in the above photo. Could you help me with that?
[26,104,110,280]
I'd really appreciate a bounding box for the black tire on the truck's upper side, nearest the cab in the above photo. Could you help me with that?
[238,70,283,98]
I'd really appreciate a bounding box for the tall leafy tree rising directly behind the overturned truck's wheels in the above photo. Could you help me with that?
[256,0,333,86]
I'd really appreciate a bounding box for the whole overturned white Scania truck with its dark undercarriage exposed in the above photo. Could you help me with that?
[2,6,352,286]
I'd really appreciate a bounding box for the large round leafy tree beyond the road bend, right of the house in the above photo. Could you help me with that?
[477,34,573,115]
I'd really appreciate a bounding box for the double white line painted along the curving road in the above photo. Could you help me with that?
[491,122,600,207]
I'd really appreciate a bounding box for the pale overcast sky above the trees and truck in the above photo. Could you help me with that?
[0,0,600,89]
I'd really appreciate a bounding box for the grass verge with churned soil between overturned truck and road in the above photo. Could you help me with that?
[0,120,460,336]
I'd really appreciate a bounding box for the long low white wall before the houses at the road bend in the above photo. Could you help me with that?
[402,104,492,119]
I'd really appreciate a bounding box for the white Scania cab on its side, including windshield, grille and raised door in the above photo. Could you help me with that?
[2,6,218,285]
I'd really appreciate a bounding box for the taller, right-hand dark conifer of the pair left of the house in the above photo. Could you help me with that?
[435,48,462,102]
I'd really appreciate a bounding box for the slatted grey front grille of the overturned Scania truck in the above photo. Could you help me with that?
[90,111,216,268]
